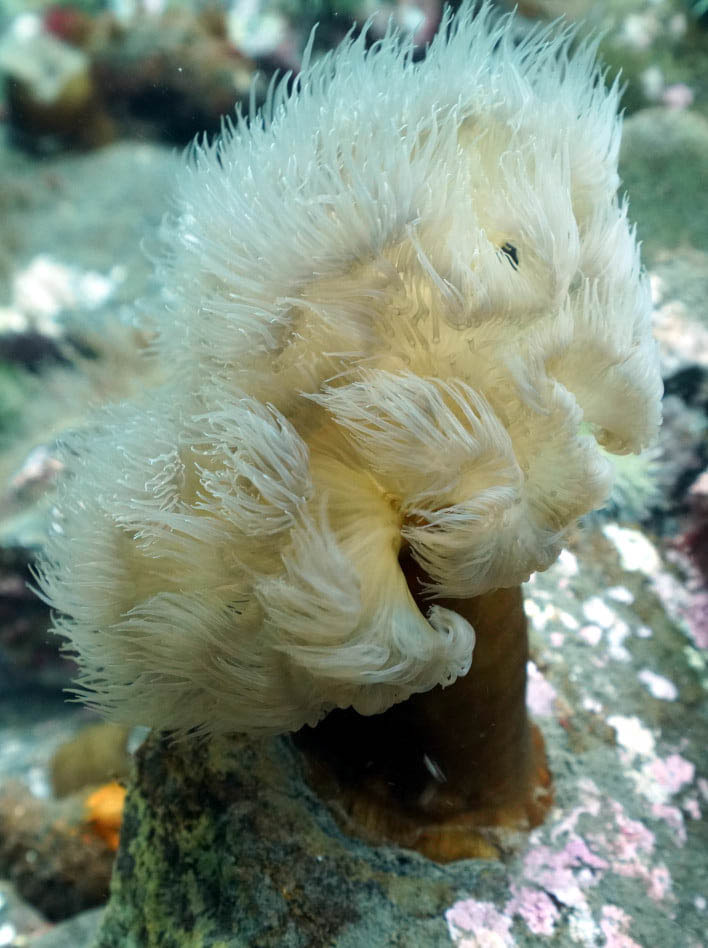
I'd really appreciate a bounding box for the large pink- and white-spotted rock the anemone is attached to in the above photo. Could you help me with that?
[96,525,708,948]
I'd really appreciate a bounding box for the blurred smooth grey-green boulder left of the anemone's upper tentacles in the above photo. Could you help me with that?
[0,142,180,314]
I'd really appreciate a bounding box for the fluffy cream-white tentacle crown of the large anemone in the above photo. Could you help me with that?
[34,3,661,733]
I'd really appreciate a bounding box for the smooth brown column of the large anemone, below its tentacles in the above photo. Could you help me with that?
[296,557,551,862]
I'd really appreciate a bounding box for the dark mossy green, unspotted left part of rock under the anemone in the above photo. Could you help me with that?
[96,738,486,948]
